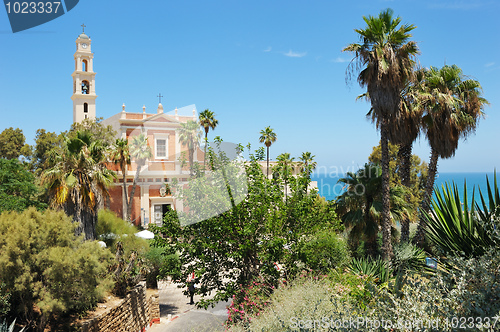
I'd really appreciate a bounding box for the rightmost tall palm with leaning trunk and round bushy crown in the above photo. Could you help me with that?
[414,65,489,245]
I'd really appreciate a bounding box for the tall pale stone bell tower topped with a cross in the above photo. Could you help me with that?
[71,24,97,122]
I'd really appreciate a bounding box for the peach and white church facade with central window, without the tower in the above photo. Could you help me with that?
[103,103,203,227]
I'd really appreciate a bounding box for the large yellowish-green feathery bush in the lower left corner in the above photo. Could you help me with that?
[0,208,112,328]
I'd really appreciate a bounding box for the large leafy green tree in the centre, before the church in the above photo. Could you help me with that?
[151,140,339,303]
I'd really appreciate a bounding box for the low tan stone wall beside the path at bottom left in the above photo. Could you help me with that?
[80,283,160,332]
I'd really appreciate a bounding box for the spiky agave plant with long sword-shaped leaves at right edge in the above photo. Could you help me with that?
[427,174,500,257]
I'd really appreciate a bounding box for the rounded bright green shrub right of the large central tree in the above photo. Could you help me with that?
[298,230,349,272]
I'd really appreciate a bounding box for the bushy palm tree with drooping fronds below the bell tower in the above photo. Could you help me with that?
[42,131,116,240]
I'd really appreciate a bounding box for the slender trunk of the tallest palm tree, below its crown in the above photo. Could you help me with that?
[380,119,393,260]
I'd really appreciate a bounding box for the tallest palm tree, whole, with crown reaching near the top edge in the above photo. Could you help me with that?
[343,9,418,259]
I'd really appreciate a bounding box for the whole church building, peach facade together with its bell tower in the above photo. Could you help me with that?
[71,28,203,228]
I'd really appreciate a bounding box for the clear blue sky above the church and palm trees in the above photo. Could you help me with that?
[0,0,500,172]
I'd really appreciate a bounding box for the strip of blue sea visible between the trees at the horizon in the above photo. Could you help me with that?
[311,172,500,204]
